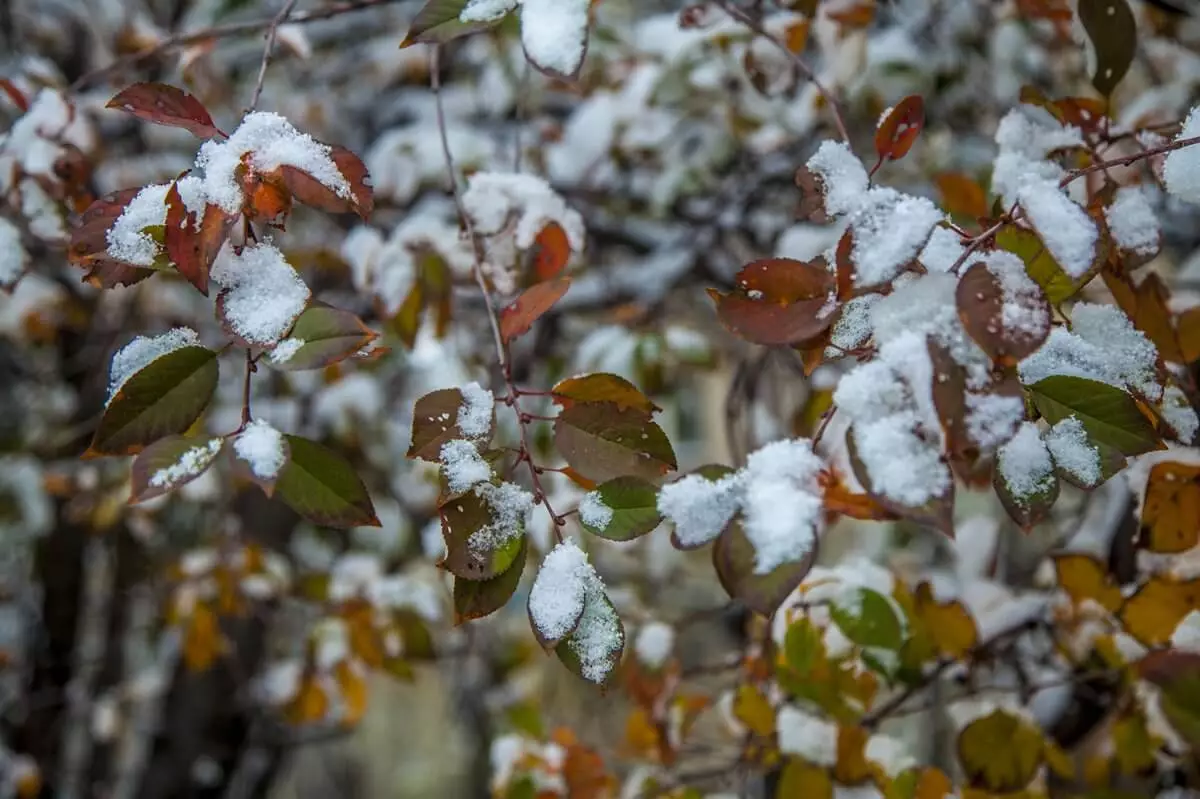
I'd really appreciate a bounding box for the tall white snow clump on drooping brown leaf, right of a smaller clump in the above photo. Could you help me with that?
[742,439,824,575]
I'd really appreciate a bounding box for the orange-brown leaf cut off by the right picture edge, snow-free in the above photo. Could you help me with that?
[1138,462,1200,554]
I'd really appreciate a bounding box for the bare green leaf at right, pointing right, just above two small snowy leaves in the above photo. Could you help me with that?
[1030,374,1164,456]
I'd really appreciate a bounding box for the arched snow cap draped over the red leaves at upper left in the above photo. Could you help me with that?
[196,112,352,214]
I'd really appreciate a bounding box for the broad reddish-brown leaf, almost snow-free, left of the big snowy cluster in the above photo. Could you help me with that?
[708,258,839,346]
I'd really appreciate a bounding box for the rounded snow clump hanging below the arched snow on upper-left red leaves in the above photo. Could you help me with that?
[211,242,312,346]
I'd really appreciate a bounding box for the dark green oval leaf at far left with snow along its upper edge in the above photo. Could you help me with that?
[88,347,217,456]
